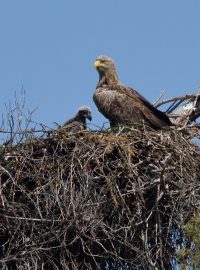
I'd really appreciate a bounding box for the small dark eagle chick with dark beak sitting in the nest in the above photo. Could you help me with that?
[61,106,92,132]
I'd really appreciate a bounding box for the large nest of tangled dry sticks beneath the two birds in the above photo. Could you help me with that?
[0,127,200,270]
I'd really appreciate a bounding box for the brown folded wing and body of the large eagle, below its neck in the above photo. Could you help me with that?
[94,84,171,129]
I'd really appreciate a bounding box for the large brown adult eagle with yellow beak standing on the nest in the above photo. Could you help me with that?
[93,55,171,129]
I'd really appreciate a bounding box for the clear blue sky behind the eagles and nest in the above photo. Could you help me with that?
[0,0,200,130]
